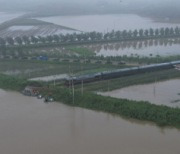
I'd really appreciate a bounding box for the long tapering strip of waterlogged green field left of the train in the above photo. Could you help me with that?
[0,60,124,78]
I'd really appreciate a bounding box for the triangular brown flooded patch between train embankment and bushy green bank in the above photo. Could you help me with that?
[101,79,180,107]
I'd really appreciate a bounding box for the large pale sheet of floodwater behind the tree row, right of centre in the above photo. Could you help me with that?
[37,14,180,32]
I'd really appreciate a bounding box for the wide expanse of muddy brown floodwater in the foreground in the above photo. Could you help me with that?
[0,90,180,154]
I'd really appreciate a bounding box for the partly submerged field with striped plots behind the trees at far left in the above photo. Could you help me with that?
[0,14,79,38]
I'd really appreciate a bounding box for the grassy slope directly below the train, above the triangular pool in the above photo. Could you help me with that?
[75,69,180,91]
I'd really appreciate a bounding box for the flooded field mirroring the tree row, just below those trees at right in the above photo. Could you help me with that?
[82,38,180,57]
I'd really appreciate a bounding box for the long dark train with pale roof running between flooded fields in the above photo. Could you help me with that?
[65,61,180,86]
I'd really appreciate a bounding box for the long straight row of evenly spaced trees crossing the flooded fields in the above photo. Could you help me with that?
[0,27,180,46]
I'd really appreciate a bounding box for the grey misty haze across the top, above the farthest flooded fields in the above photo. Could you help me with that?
[0,0,180,17]
